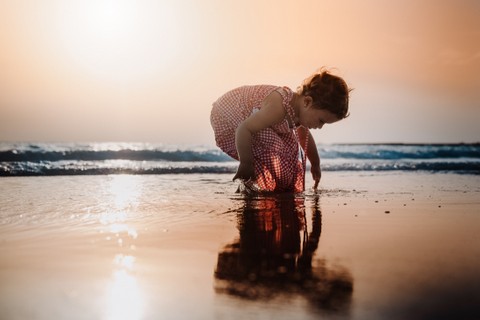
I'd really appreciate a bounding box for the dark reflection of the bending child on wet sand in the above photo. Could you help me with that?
[215,194,353,311]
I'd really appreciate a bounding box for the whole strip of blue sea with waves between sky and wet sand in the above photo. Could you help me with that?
[0,142,480,176]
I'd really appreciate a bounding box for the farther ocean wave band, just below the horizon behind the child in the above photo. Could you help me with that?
[0,143,480,162]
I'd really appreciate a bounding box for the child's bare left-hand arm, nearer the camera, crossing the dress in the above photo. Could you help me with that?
[233,91,286,180]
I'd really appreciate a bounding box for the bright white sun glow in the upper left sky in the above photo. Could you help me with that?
[57,0,185,82]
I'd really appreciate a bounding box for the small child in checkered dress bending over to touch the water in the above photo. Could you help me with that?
[210,71,349,192]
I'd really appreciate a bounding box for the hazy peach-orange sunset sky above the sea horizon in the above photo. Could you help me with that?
[0,0,480,145]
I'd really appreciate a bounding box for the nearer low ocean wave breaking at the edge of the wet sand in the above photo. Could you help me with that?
[0,160,480,176]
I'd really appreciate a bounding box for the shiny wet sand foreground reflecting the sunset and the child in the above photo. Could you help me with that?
[0,172,480,319]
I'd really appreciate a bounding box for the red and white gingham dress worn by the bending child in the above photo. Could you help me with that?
[210,85,305,192]
